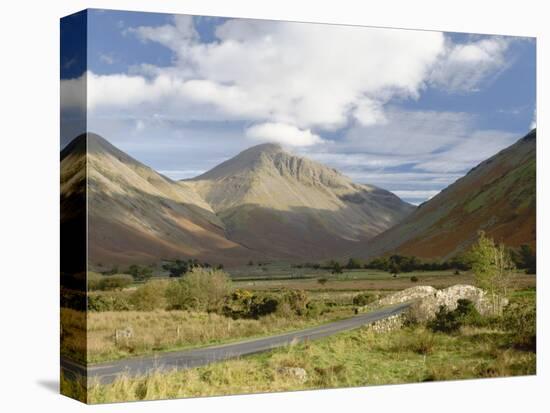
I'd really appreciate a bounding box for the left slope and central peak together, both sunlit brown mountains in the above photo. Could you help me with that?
[61,133,414,268]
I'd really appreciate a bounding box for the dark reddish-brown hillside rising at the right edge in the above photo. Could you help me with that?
[362,130,536,258]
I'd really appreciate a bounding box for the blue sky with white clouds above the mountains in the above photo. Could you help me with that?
[61,10,536,204]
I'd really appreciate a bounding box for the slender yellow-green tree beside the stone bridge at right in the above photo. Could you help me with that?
[470,231,514,315]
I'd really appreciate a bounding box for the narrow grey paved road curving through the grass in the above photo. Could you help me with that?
[61,303,410,383]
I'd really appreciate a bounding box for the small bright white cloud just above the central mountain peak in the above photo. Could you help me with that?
[246,123,323,146]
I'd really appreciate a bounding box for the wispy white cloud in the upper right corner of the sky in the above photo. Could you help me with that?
[430,36,511,92]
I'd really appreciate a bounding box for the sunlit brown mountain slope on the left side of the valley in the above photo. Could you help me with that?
[62,133,260,267]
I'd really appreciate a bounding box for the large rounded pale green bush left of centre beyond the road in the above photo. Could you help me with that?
[166,268,231,312]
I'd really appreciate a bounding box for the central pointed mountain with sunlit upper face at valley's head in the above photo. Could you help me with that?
[188,144,414,260]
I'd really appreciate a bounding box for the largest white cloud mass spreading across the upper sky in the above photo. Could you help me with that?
[62,16,520,146]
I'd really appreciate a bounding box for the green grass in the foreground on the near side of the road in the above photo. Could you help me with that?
[72,327,536,403]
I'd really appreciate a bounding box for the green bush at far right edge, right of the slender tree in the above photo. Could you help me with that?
[502,303,537,350]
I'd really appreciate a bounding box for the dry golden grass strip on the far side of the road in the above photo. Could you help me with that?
[61,308,351,363]
